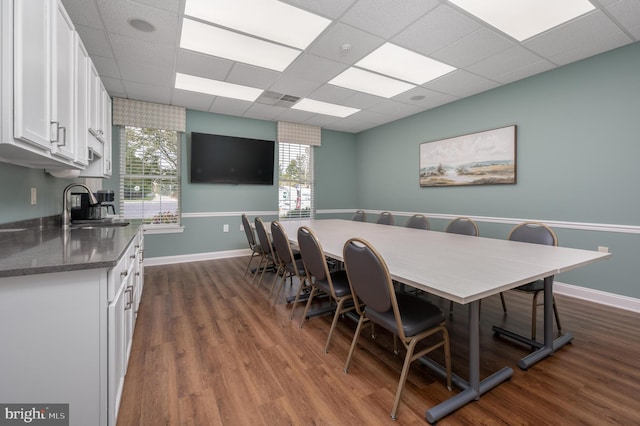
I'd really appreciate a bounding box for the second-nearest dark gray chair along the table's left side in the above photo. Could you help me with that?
[298,226,354,353]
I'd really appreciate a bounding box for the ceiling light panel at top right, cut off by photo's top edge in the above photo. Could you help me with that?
[449,0,595,41]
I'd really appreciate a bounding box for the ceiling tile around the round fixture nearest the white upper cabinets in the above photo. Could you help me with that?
[98,0,178,46]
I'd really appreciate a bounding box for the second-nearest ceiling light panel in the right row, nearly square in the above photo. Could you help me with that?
[355,43,455,84]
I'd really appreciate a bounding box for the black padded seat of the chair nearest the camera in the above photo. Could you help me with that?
[364,292,444,337]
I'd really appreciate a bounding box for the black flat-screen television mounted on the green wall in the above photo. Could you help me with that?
[191,133,275,185]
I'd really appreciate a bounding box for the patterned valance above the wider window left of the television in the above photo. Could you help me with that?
[113,98,187,132]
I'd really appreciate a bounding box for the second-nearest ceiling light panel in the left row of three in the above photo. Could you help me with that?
[180,18,301,71]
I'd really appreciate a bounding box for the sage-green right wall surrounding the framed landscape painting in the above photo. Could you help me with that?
[357,43,640,298]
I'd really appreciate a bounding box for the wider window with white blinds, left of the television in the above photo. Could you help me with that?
[120,126,180,226]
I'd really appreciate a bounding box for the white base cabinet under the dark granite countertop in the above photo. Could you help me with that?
[0,231,144,426]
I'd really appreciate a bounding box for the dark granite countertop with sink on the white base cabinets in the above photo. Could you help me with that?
[0,218,141,277]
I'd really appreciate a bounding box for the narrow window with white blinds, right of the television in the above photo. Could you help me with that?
[278,142,314,218]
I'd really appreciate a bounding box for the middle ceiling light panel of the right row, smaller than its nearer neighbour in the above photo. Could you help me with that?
[329,67,416,98]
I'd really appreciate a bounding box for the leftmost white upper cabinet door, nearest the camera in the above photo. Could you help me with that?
[13,0,52,151]
